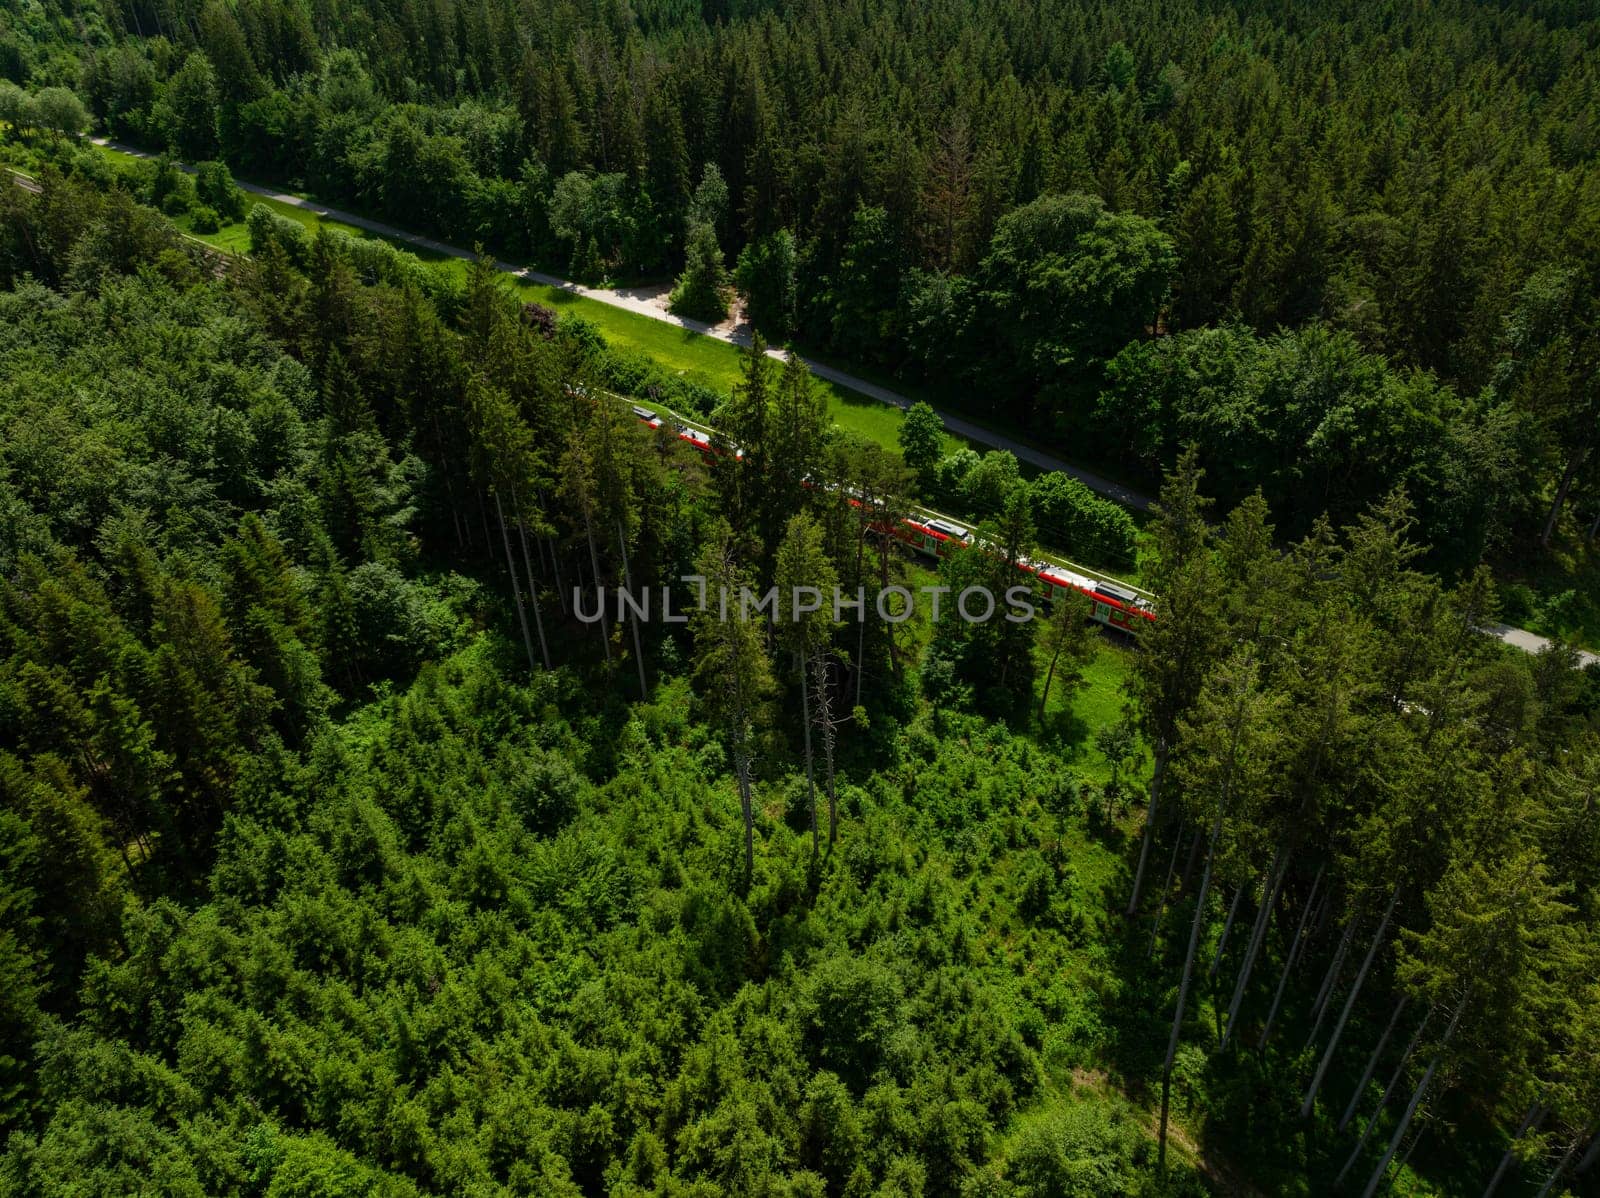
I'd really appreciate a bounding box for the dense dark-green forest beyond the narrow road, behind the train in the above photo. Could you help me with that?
[9,0,1600,571]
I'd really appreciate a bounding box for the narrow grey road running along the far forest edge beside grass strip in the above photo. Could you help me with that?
[75,138,1600,665]
